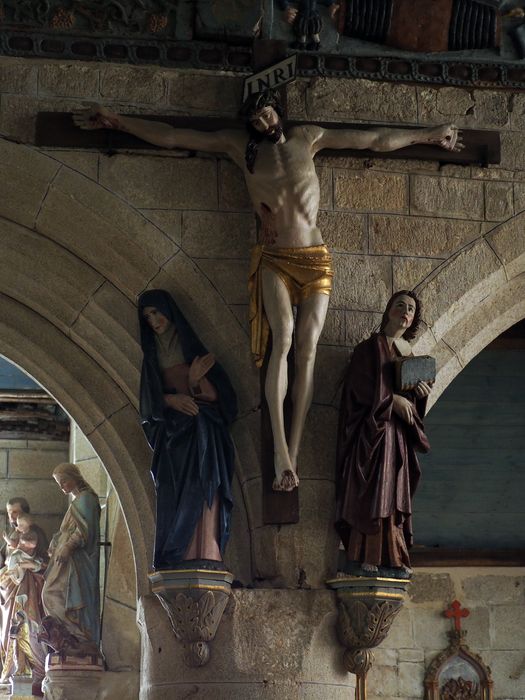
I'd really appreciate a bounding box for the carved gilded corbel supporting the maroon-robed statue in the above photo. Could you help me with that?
[327,576,410,700]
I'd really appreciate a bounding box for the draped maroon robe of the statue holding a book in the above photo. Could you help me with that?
[336,333,430,566]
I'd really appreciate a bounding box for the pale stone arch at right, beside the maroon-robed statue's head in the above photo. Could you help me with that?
[415,212,525,410]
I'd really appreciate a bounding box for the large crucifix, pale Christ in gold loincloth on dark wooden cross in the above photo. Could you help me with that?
[37,40,499,524]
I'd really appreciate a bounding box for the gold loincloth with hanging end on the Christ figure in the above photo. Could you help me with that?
[248,245,334,367]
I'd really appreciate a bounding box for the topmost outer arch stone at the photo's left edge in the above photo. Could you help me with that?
[0,140,60,227]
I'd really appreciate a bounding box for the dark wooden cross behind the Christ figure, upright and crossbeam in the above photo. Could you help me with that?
[35,40,500,524]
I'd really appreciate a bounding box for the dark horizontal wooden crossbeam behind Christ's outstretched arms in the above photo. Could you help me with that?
[35,112,501,166]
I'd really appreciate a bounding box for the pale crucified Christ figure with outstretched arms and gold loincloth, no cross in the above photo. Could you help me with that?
[74,91,463,491]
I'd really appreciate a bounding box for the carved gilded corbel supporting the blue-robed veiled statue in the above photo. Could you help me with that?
[149,569,233,668]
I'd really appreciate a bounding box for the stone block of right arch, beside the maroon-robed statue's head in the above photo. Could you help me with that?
[418,239,504,338]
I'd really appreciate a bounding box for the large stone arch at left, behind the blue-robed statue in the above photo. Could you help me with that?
[0,139,258,595]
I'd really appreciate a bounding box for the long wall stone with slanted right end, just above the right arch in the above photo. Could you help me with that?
[370,214,480,258]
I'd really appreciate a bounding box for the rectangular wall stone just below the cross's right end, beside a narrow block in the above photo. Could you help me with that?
[410,175,485,220]
